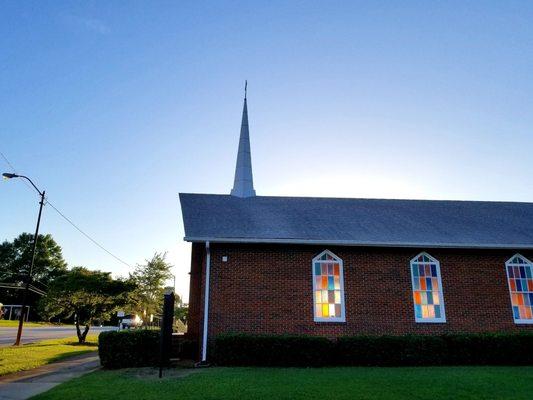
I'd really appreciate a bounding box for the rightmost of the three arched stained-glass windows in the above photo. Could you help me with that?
[505,254,533,324]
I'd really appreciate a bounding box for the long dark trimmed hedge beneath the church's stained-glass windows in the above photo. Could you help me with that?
[210,333,533,367]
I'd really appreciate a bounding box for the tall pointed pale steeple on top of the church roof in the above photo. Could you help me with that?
[231,81,255,197]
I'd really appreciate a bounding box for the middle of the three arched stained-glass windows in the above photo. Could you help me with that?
[411,253,446,322]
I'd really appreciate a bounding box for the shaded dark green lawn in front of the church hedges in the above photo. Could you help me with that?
[34,367,533,400]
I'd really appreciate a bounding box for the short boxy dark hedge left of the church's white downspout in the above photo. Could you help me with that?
[98,330,160,369]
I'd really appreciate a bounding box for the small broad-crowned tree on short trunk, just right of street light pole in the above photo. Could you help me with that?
[40,267,135,343]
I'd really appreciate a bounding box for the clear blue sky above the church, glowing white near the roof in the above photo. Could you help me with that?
[0,1,533,294]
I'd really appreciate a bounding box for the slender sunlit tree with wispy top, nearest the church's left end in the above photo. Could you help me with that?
[130,253,172,315]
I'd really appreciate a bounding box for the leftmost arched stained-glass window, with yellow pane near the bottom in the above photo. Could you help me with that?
[312,250,346,322]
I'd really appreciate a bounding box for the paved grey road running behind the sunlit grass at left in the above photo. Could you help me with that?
[0,326,116,346]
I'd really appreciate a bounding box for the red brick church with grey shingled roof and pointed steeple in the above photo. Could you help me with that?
[180,88,533,361]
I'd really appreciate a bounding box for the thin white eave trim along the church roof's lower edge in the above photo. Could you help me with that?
[183,236,533,250]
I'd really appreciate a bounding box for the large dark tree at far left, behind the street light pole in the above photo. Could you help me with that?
[0,233,67,316]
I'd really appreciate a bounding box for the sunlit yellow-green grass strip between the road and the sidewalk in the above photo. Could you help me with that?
[0,335,98,375]
